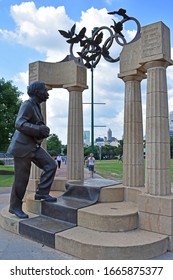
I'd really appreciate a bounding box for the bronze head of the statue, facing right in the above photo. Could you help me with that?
[27,81,49,103]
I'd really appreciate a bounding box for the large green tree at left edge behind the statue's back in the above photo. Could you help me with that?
[0,78,23,152]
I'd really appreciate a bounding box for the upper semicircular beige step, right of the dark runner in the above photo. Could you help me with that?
[77,202,138,232]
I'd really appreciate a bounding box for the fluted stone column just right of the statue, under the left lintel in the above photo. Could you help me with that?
[67,86,84,181]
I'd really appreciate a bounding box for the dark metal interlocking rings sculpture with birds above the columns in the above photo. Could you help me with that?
[59,8,141,68]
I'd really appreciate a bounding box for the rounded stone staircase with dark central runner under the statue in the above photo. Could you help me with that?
[0,179,168,260]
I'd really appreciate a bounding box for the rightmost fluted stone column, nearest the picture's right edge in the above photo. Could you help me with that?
[145,60,171,195]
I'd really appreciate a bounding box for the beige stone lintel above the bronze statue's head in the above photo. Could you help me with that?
[29,60,87,89]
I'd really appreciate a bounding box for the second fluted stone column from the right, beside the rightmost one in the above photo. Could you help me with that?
[123,71,144,187]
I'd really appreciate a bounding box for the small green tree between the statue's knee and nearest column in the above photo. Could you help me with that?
[47,134,61,156]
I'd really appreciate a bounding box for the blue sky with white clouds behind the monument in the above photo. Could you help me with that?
[0,0,173,144]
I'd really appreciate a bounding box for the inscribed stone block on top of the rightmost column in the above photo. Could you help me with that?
[139,21,172,65]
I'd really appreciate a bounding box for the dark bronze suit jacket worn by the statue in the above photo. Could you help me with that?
[8,98,44,157]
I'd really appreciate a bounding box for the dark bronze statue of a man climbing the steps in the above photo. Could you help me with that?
[8,82,57,218]
